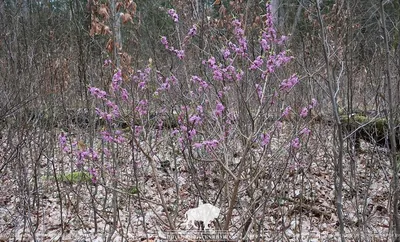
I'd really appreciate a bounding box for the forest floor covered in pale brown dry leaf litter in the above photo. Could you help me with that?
[0,125,391,241]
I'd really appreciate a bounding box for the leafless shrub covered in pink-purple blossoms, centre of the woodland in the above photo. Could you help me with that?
[59,1,317,233]
